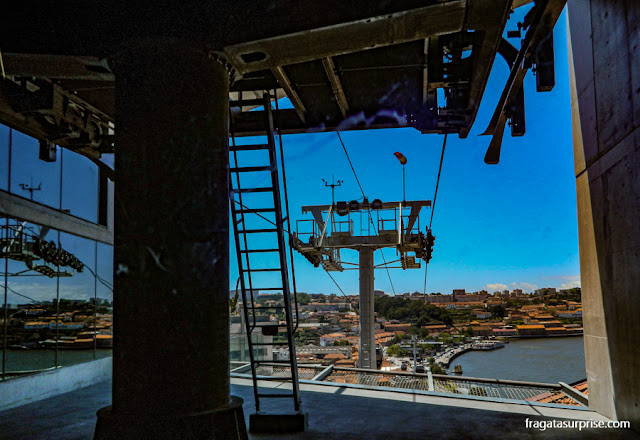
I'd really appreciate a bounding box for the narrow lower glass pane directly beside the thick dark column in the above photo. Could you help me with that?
[95,243,113,359]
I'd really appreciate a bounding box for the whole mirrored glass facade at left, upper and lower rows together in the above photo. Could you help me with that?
[0,126,113,380]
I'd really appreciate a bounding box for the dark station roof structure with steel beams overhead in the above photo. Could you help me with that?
[0,0,564,168]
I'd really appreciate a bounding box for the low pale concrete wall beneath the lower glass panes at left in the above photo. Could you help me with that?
[0,357,112,411]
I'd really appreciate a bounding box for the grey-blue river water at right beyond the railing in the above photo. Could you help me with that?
[449,336,586,383]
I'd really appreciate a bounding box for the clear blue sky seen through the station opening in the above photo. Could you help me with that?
[231,6,580,294]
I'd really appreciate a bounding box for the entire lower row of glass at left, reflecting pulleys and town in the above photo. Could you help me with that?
[0,218,113,379]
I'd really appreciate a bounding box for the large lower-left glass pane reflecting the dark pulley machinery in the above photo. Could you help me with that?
[0,218,58,378]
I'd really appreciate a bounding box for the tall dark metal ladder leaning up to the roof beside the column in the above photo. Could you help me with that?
[229,93,300,414]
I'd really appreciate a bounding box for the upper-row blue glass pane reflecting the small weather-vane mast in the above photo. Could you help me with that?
[11,130,60,208]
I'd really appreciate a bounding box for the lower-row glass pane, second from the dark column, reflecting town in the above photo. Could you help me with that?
[57,230,96,366]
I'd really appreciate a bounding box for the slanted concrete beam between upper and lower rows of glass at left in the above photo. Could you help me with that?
[0,190,113,245]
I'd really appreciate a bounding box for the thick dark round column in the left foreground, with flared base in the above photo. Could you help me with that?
[96,39,246,439]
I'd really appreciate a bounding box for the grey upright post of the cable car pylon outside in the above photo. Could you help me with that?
[358,247,377,369]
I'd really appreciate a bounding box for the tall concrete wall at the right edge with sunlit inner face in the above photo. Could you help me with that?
[568,0,640,429]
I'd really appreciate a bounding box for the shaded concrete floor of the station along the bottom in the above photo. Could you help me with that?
[0,379,640,440]
